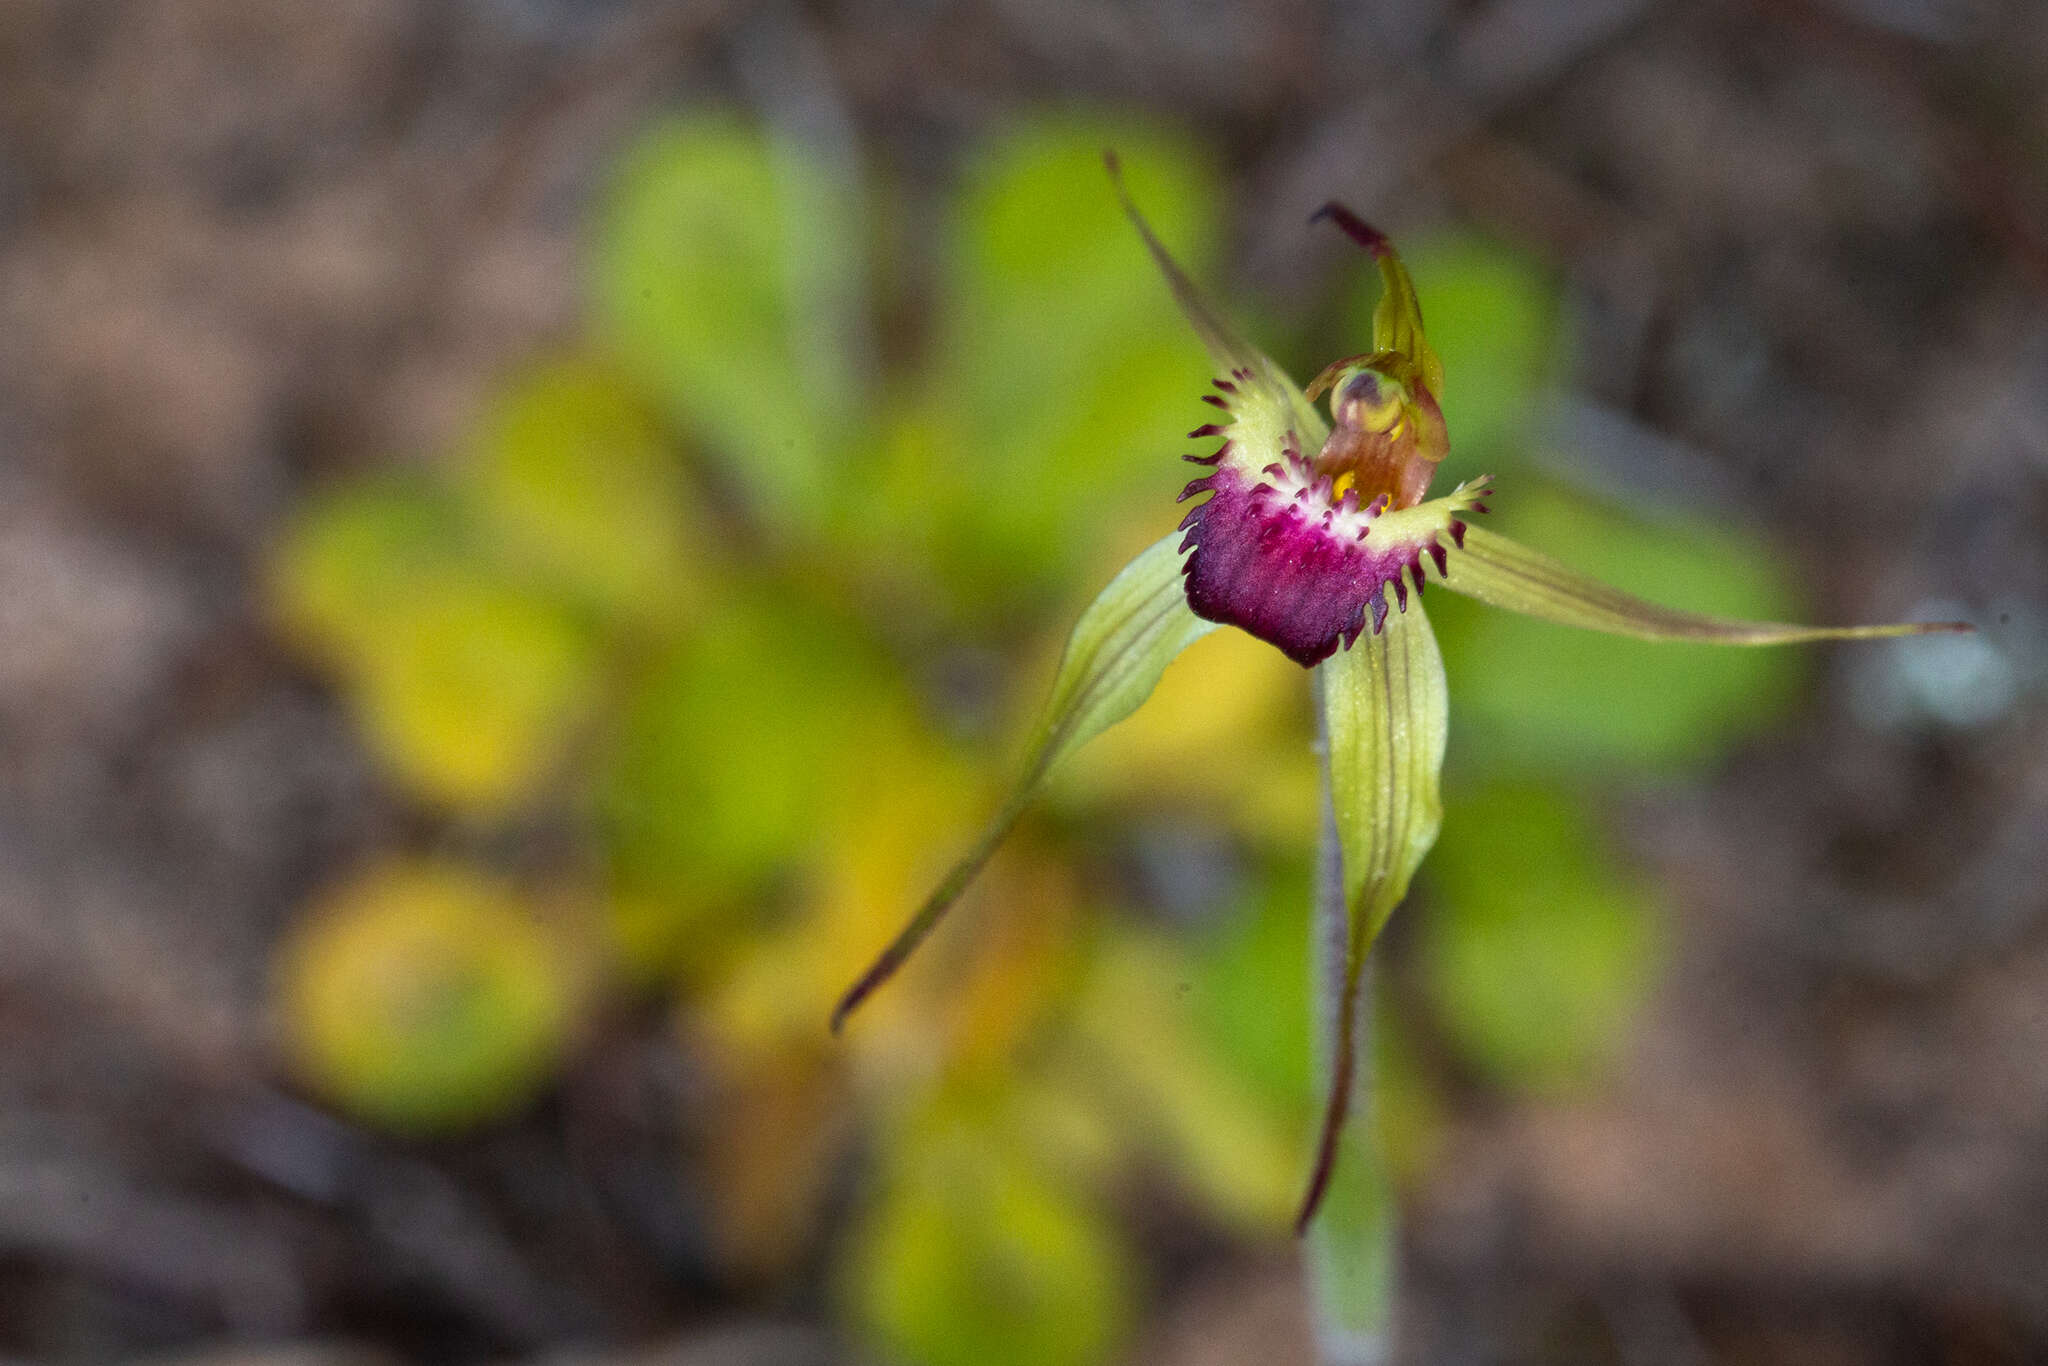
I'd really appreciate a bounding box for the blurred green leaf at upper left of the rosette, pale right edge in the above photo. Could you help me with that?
[590,115,866,532]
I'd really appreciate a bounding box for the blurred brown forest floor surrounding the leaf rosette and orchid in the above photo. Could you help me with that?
[0,0,2048,1364]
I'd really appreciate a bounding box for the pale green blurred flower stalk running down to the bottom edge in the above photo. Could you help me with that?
[1305,670,1397,1366]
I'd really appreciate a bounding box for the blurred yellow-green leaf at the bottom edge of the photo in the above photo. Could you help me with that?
[846,1106,1135,1366]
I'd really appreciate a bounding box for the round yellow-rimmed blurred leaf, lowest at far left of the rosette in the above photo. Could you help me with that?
[279,862,578,1133]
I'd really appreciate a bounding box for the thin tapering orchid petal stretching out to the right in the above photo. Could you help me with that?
[1444,526,1974,645]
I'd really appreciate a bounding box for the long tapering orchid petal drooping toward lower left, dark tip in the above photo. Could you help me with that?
[831,532,1217,1032]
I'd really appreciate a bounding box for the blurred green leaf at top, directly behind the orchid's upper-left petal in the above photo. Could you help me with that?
[889,117,1221,606]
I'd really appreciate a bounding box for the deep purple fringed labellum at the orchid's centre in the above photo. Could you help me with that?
[1182,465,1430,666]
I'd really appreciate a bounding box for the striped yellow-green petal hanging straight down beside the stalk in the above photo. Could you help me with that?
[1296,600,1450,1231]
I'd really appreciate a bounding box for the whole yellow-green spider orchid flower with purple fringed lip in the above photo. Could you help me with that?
[831,156,1970,1233]
